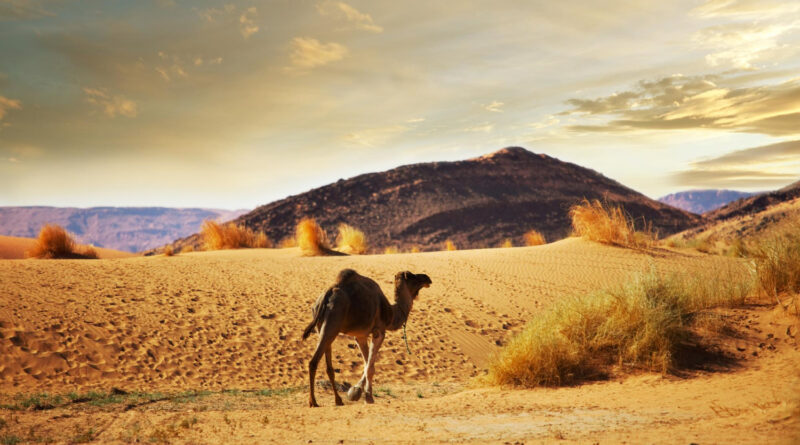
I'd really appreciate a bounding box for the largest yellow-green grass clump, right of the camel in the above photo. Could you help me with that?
[481,269,752,387]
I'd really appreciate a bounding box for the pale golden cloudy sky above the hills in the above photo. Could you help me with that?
[0,0,800,209]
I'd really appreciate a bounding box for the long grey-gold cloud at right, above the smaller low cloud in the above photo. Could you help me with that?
[561,75,800,136]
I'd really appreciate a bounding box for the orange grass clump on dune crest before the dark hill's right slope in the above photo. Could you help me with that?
[569,199,655,248]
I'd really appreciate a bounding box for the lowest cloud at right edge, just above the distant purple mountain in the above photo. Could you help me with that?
[672,140,800,188]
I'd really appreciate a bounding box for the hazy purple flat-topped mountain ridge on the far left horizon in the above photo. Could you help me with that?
[0,207,246,252]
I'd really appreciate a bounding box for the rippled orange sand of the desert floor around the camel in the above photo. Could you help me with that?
[0,239,800,444]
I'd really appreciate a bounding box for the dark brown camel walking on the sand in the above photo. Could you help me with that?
[303,269,431,407]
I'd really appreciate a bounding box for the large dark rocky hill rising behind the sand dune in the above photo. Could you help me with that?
[164,147,700,250]
